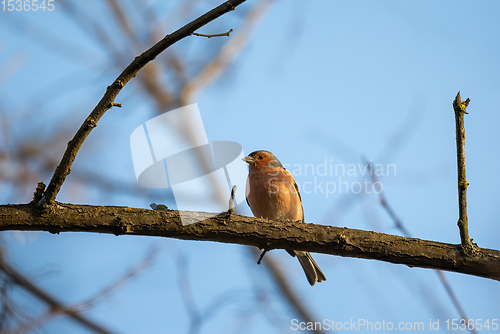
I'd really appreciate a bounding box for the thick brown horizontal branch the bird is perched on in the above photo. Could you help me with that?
[0,203,500,281]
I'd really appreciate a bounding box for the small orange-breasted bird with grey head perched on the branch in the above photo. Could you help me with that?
[243,151,326,286]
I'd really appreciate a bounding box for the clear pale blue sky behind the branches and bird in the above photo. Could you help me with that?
[0,1,500,333]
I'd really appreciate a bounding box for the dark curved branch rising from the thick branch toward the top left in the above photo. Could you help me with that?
[44,0,245,204]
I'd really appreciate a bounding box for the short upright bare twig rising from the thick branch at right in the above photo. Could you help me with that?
[453,92,472,248]
